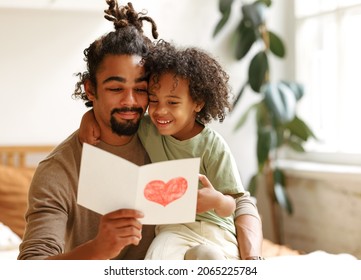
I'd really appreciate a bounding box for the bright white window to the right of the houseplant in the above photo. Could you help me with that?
[295,0,361,164]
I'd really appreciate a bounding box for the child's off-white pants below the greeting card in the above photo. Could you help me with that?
[145,221,240,260]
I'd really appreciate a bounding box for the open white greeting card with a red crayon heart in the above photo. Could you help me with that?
[78,143,200,224]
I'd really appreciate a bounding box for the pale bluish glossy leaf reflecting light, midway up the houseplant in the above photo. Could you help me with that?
[262,83,296,123]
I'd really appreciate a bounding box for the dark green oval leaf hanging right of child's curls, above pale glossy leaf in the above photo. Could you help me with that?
[248,51,269,92]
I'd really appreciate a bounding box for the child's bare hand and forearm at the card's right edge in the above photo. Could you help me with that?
[197,175,236,217]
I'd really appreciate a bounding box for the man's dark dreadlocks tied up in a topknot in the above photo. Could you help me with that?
[72,0,158,107]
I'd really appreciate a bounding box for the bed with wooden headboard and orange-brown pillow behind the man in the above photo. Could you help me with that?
[0,145,354,259]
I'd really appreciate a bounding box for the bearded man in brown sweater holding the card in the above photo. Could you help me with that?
[18,1,157,259]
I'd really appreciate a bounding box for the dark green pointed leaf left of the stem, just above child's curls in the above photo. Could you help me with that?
[235,20,257,60]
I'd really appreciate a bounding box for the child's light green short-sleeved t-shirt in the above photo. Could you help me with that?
[138,115,245,234]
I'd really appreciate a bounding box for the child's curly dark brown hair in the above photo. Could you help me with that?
[144,40,231,124]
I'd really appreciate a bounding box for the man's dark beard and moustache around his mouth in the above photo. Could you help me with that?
[110,107,143,136]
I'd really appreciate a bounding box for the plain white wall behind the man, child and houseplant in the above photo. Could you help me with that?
[0,0,289,186]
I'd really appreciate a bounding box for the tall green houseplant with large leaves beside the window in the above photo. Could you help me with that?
[213,0,315,223]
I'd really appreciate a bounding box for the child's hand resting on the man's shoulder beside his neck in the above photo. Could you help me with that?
[78,109,100,145]
